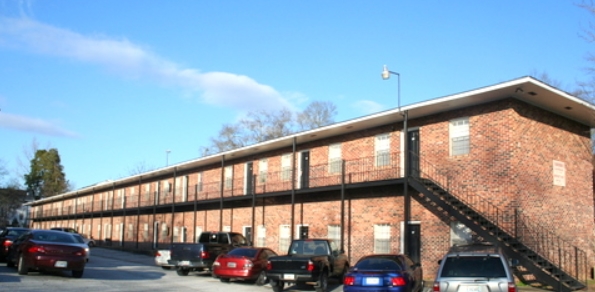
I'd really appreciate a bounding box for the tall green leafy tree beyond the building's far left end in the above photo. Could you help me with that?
[25,148,68,199]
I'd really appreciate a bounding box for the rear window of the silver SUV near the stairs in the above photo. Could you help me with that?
[440,256,506,278]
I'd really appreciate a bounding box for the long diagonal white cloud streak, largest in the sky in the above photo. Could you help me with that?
[0,17,293,110]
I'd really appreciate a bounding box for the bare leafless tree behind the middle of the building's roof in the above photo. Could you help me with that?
[199,101,337,156]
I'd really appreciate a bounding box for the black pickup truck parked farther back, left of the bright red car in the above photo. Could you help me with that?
[168,232,250,276]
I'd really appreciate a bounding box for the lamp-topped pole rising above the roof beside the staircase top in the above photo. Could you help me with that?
[382,65,411,255]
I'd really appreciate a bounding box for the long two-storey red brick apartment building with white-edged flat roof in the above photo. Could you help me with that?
[25,77,595,290]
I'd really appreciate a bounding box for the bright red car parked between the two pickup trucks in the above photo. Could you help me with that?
[213,247,277,286]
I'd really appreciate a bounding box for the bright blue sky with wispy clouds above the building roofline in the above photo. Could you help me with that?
[0,0,594,188]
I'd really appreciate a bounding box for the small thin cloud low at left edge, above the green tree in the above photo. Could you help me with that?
[0,112,77,137]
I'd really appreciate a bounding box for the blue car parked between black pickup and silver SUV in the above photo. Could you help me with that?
[343,254,424,292]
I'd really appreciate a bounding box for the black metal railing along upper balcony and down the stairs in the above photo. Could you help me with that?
[33,153,586,280]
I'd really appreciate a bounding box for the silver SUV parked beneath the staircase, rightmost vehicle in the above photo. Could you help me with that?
[433,243,517,292]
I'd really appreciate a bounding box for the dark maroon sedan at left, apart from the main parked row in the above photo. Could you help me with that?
[6,229,86,278]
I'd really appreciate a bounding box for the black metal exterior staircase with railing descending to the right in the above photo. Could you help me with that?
[409,160,588,292]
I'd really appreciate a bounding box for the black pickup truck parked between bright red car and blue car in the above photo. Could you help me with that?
[267,239,349,292]
